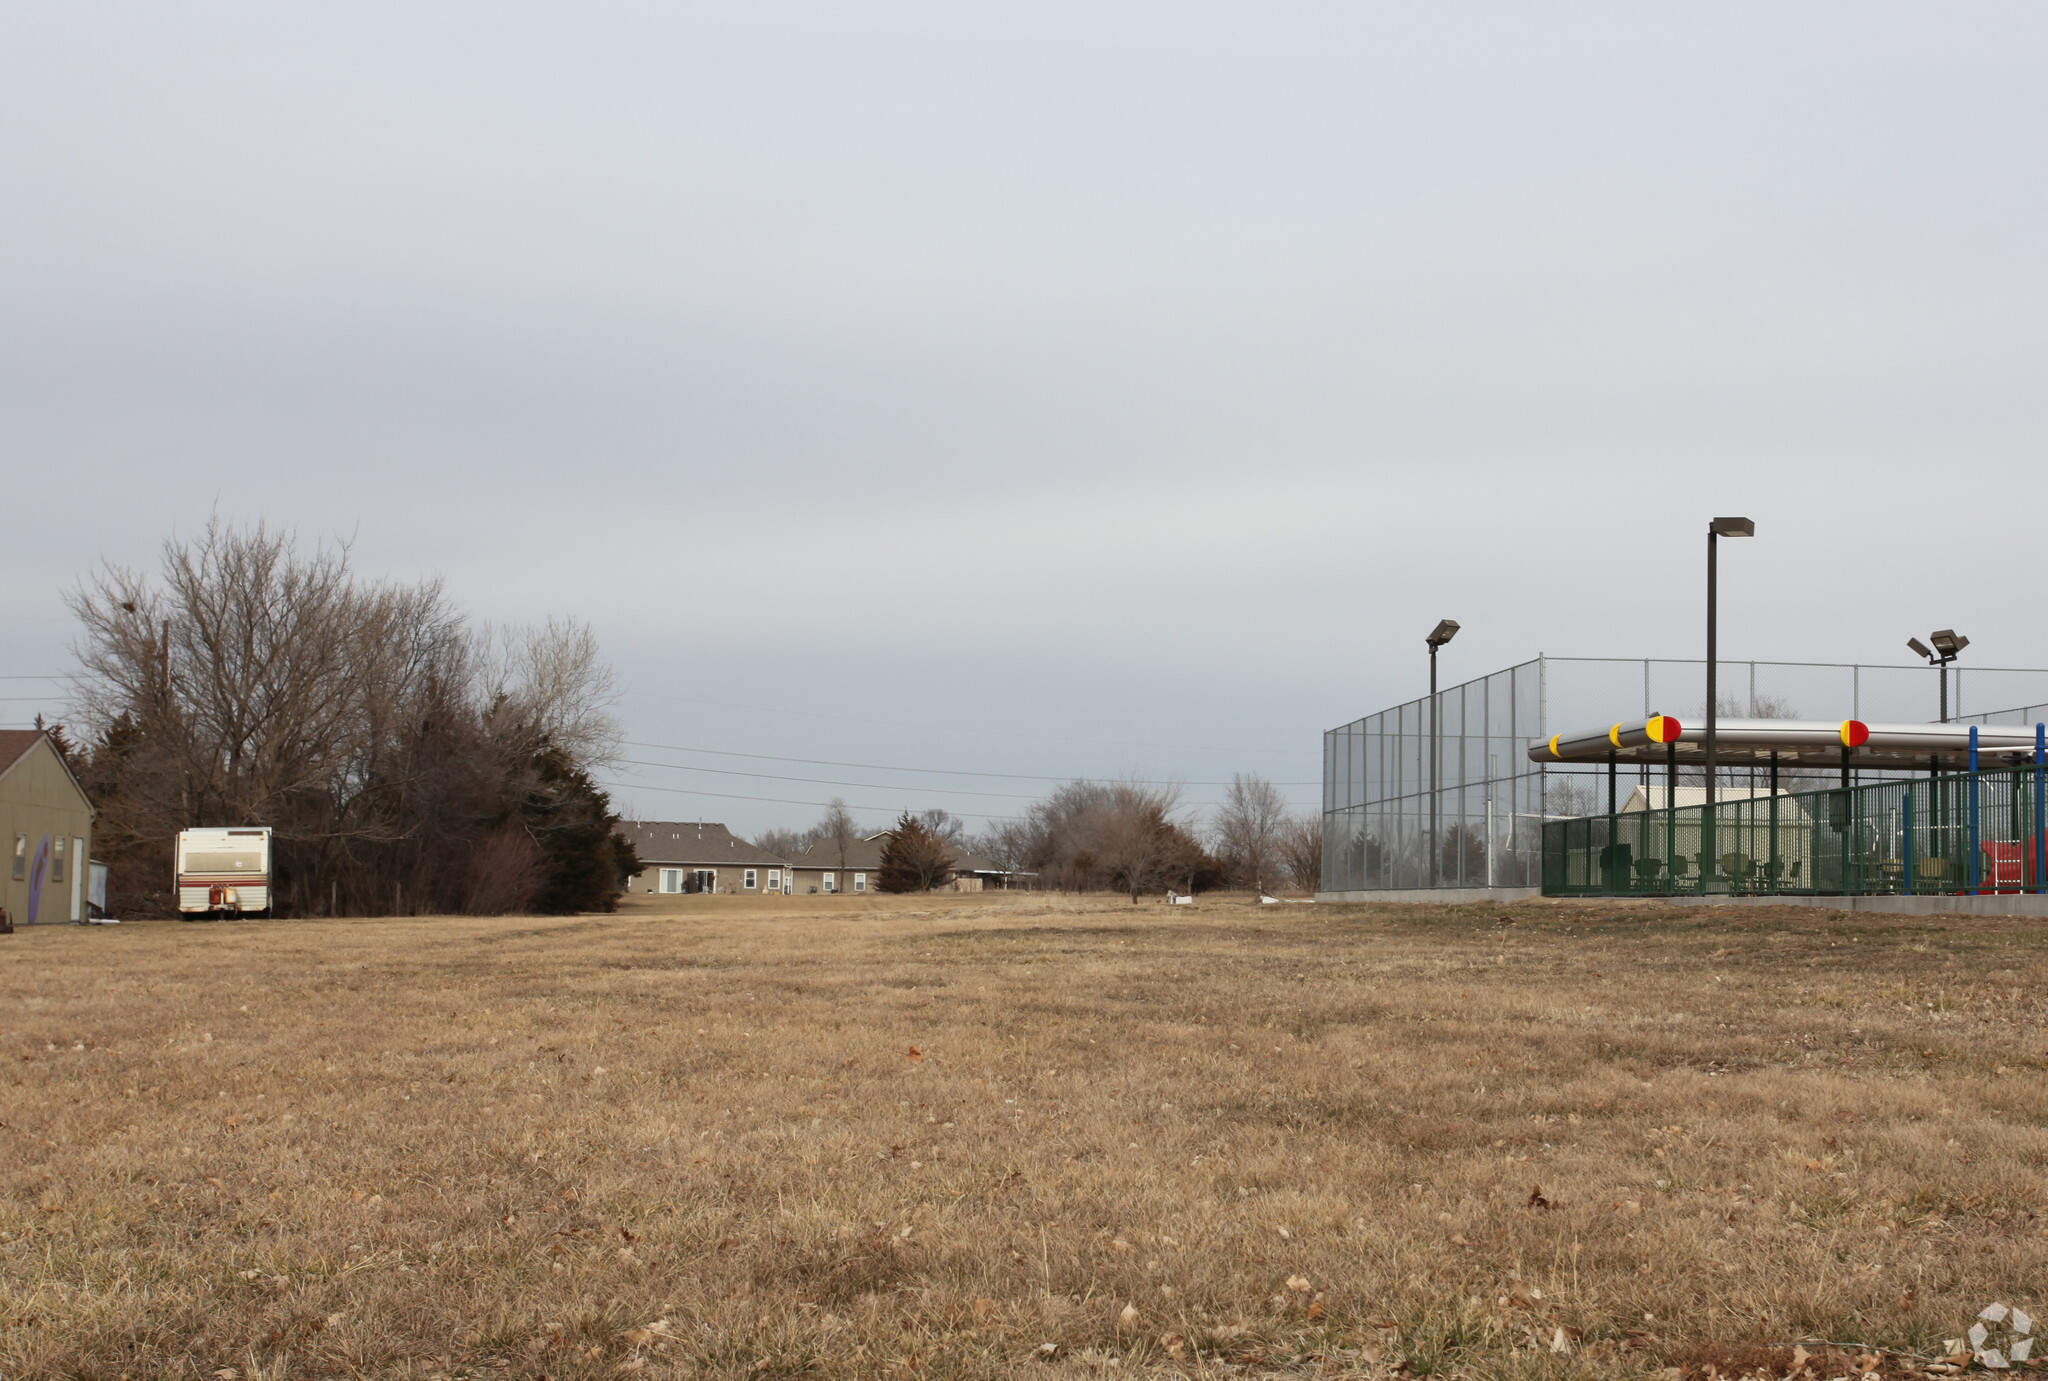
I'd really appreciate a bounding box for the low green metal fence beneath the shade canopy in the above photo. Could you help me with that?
[1542,764,2048,897]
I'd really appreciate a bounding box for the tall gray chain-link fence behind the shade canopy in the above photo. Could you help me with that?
[1323,656,2048,895]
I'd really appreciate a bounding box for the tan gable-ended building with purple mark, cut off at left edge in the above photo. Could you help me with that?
[0,729,92,926]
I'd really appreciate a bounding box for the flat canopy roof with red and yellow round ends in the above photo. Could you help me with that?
[1528,715,2036,770]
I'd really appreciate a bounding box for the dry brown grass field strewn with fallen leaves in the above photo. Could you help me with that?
[0,895,2048,1381]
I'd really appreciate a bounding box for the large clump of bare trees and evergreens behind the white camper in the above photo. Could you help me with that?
[68,520,639,916]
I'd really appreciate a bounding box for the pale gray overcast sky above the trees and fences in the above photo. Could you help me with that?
[0,0,2048,832]
